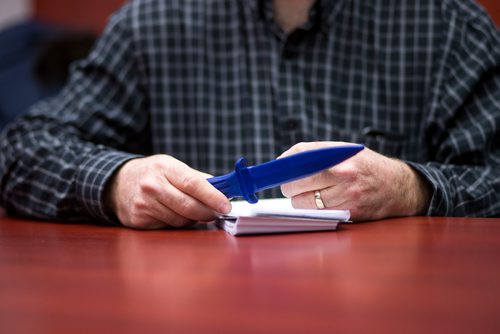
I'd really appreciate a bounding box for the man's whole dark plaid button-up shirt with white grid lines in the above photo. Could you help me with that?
[0,0,500,221]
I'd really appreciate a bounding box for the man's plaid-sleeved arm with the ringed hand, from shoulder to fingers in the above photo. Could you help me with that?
[282,0,500,220]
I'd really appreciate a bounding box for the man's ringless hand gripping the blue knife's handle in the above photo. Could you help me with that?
[106,155,231,229]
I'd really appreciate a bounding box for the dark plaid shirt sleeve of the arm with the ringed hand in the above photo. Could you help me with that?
[408,1,500,217]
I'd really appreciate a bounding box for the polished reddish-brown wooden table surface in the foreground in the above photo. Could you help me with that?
[0,217,500,333]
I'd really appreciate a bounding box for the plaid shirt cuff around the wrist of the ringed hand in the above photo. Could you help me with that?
[405,161,453,217]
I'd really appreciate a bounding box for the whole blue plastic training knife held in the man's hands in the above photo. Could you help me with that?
[208,145,365,203]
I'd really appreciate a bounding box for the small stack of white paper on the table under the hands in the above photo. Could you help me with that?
[218,198,350,235]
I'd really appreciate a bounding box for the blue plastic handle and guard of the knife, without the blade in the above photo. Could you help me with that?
[208,158,259,204]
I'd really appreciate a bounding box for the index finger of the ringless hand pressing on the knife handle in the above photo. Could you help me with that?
[165,165,231,213]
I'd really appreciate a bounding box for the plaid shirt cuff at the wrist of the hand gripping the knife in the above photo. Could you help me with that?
[76,150,142,225]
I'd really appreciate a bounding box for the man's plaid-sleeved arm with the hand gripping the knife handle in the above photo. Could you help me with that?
[0,5,230,228]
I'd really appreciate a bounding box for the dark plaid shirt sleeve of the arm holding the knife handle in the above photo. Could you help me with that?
[0,6,148,222]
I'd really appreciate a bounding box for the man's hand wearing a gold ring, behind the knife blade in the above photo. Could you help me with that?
[281,142,432,221]
